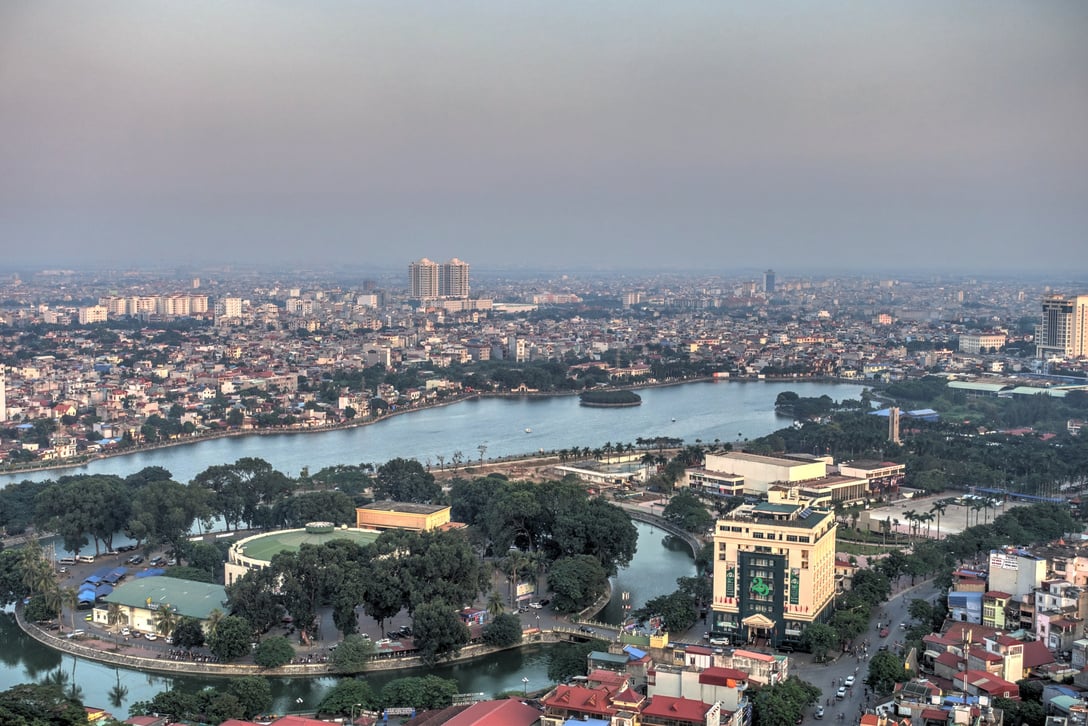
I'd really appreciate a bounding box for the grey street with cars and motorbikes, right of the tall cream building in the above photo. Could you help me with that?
[790,581,938,725]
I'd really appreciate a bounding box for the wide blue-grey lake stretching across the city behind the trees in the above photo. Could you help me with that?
[0,382,862,485]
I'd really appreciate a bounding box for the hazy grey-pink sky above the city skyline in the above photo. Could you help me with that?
[0,0,1088,274]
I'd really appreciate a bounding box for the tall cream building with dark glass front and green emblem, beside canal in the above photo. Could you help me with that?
[710,487,837,645]
